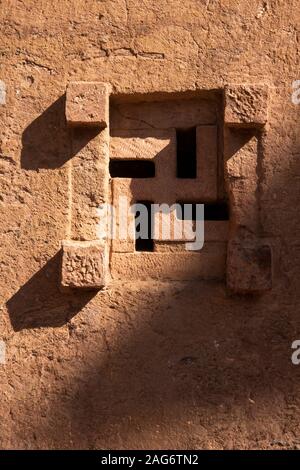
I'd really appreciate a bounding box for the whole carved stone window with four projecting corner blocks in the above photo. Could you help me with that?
[62,82,272,293]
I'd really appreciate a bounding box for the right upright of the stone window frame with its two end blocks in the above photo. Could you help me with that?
[224,85,272,294]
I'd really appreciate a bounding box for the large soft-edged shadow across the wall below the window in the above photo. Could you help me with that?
[49,133,300,449]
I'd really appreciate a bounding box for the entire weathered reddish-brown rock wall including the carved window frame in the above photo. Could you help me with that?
[0,0,300,449]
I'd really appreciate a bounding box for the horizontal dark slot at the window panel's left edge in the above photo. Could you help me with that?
[109,160,155,178]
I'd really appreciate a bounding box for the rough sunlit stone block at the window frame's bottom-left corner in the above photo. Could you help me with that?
[61,240,107,289]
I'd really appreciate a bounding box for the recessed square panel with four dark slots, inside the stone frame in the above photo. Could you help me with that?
[110,92,229,280]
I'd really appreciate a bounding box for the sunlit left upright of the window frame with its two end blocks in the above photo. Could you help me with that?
[61,82,110,289]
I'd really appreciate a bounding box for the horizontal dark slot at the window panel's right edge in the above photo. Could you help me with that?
[177,202,229,220]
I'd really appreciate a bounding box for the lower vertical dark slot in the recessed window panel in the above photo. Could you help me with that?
[135,201,154,251]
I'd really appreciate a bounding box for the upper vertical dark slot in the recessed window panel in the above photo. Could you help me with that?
[176,127,197,178]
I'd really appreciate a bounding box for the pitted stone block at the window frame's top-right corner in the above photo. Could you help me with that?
[224,85,268,127]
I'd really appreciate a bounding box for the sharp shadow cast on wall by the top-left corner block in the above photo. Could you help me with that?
[21,95,99,170]
